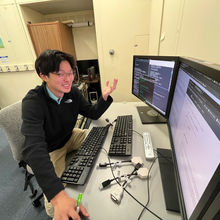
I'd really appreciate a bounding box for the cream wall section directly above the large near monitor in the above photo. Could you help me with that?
[159,0,220,64]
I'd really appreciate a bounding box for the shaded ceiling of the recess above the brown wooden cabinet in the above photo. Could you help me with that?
[22,0,93,15]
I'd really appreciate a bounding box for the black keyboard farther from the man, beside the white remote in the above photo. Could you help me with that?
[108,115,133,156]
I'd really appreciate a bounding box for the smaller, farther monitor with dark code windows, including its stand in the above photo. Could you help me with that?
[132,55,178,124]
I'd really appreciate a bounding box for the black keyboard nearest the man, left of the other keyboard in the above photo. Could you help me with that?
[61,125,110,185]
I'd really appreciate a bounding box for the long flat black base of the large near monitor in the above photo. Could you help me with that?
[157,148,180,213]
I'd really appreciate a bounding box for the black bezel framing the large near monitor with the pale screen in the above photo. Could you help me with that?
[167,57,220,220]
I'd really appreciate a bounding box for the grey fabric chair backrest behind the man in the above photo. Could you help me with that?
[0,100,25,161]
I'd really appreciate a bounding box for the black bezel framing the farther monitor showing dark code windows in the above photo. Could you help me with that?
[131,55,179,119]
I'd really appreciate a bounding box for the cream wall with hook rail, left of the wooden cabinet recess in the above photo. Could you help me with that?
[0,3,40,108]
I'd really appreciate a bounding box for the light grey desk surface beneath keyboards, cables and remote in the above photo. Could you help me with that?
[66,102,181,220]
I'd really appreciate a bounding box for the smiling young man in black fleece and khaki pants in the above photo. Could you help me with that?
[21,50,118,220]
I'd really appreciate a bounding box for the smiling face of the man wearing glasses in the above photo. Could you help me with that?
[41,60,74,98]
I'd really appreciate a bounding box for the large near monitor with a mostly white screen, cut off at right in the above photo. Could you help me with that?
[165,57,220,220]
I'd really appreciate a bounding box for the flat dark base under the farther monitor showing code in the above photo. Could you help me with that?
[137,106,167,124]
